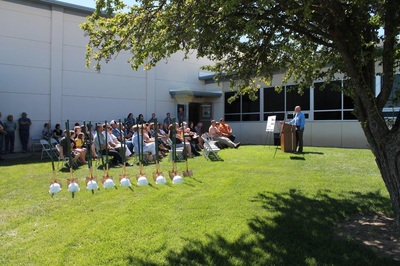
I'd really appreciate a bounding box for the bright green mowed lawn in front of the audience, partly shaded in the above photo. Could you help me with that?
[0,146,395,265]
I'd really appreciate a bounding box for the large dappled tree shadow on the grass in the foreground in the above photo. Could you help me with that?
[127,189,399,265]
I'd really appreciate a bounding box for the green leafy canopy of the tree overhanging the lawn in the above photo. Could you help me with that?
[81,0,400,105]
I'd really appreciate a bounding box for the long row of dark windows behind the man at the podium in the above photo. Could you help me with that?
[225,78,358,121]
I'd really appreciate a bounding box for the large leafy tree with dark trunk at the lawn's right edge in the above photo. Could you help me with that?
[82,0,400,223]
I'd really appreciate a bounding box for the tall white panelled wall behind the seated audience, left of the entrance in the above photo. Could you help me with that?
[0,0,219,150]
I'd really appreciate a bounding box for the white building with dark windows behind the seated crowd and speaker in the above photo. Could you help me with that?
[0,0,376,150]
